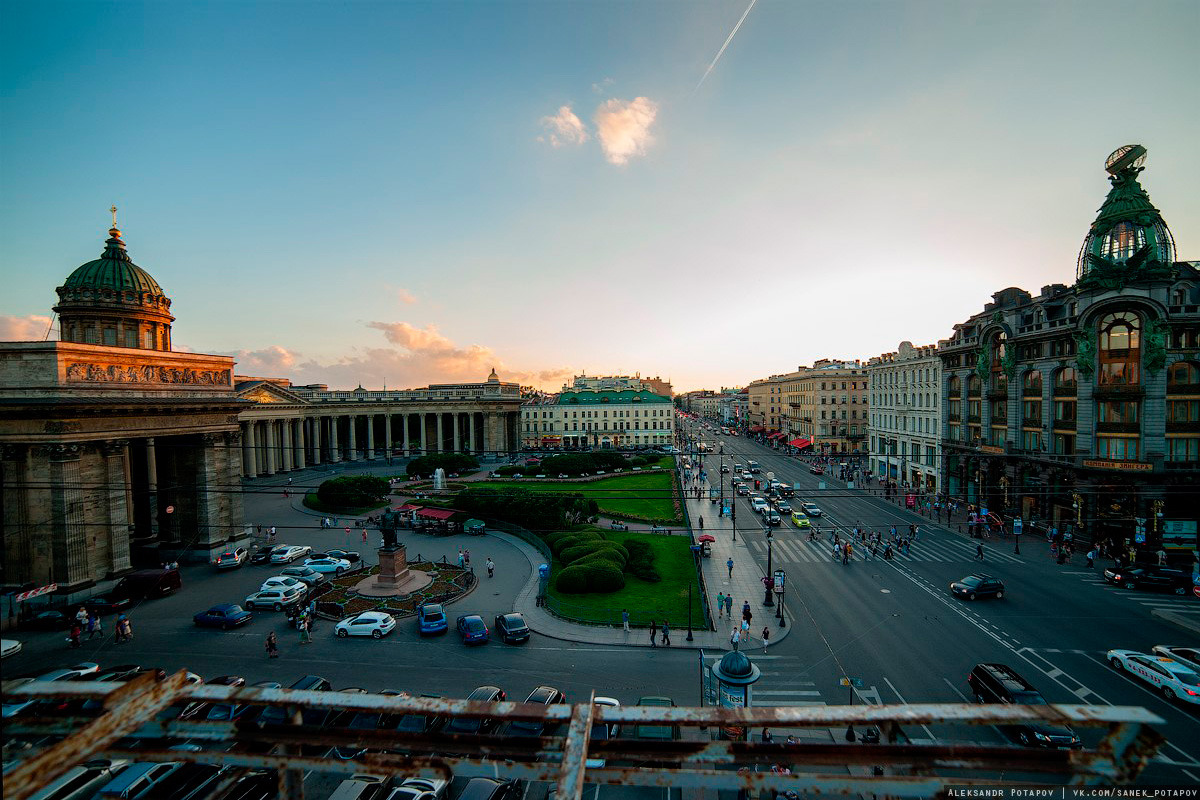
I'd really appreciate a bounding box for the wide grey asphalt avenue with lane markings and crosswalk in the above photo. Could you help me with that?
[686,422,1200,783]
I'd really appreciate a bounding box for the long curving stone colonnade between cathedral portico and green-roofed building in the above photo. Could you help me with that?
[240,409,518,476]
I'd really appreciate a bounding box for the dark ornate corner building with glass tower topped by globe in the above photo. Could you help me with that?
[938,145,1200,566]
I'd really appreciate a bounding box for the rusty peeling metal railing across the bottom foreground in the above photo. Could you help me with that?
[4,672,1163,800]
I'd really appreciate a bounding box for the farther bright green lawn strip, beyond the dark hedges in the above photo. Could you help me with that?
[475,469,683,525]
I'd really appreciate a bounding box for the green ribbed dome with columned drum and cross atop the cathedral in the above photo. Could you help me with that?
[54,206,175,350]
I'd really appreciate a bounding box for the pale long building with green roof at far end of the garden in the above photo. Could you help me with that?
[521,390,674,450]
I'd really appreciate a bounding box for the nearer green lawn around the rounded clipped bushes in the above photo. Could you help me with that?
[547,528,706,638]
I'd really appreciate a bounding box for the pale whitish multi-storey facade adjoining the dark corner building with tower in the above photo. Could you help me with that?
[866,342,942,494]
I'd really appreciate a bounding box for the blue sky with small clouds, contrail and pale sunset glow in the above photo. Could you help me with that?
[0,0,1200,391]
